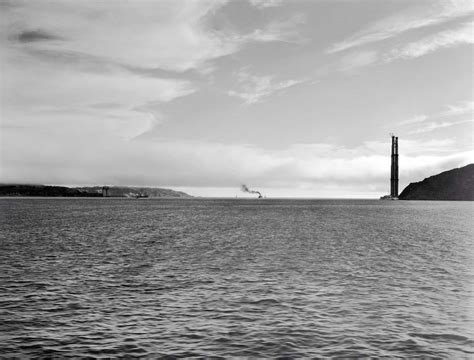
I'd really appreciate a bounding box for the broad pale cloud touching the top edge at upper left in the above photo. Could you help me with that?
[2,0,235,71]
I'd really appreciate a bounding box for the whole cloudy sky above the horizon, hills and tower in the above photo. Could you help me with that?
[0,0,474,198]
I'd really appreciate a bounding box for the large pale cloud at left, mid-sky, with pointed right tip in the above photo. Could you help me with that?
[1,45,195,139]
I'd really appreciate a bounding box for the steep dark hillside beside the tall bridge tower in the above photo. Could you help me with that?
[399,164,474,200]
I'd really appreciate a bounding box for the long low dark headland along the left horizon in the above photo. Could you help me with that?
[0,184,192,198]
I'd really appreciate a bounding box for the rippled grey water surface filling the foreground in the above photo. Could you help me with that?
[0,199,474,358]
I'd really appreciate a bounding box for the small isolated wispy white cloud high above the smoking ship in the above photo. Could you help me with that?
[228,70,306,105]
